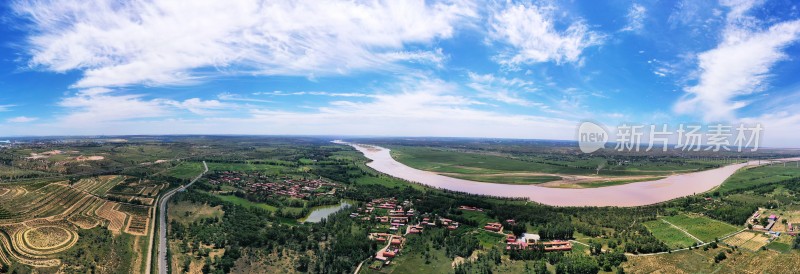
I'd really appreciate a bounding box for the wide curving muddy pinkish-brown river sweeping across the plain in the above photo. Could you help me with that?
[337,142,796,207]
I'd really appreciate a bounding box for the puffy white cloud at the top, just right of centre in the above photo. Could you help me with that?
[489,3,603,67]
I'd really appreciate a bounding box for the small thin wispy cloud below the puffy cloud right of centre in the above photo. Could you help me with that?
[467,72,543,106]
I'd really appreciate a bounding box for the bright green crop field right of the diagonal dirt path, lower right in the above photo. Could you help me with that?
[664,214,740,242]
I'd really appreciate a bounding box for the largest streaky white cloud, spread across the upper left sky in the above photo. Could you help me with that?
[13,0,477,88]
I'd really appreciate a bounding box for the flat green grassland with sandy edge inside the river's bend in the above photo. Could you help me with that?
[390,146,720,185]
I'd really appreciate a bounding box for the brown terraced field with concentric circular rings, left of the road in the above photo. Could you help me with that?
[0,178,158,268]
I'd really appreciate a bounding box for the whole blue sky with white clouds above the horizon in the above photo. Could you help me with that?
[0,0,800,147]
